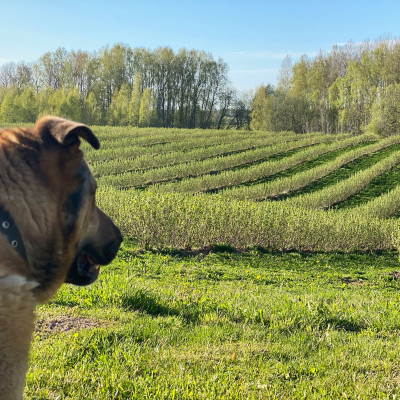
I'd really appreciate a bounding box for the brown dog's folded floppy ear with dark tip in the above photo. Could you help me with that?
[34,116,100,149]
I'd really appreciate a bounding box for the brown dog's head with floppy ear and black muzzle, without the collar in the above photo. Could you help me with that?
[0,117,122,302]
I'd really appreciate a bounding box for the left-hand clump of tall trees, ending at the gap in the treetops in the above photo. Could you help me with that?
[0,44,251,129]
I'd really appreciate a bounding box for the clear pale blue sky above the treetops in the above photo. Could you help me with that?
[0,0,400,90]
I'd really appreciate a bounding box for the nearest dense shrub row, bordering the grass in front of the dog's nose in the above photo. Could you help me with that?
[98,187,400,252]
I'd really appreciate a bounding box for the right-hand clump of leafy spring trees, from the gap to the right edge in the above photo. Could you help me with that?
[250,40,400,136]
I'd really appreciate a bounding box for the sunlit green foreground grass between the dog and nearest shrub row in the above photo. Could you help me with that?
[26,239,400,400]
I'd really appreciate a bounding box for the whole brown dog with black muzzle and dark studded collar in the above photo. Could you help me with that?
[0,117,122,400]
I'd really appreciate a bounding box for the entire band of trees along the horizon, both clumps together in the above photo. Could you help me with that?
[5,39,400,136]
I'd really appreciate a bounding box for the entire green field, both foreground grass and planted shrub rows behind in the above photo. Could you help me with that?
[26,127,400,399]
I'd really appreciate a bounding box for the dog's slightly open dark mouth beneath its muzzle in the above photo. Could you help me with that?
[65,252,100,286]
